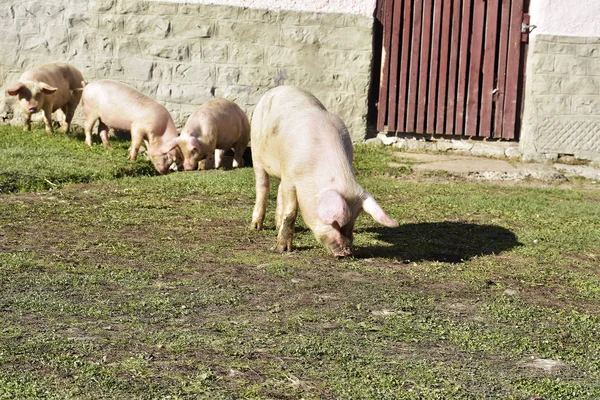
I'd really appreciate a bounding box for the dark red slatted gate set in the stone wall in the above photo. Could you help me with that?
[377,0,528,139]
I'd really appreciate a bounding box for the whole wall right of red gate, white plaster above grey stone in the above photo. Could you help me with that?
[520,0,600,163]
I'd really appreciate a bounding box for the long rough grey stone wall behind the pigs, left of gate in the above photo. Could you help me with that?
[0,0,373,141]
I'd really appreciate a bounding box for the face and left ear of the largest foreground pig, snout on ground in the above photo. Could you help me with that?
[313,190,358,257]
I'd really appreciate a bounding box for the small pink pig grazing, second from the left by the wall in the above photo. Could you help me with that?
[82,79,182,174]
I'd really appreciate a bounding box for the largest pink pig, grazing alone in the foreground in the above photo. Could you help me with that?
[251,86,398,257]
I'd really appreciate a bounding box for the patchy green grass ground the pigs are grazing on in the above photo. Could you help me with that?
[0,126,600,399]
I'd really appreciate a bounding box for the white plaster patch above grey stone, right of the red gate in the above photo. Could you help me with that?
[529,0,600,36]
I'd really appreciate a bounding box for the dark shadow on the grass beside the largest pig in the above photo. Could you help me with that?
[354,222,522,263]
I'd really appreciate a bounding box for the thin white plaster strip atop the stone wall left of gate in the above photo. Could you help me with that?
[150,0,376,16]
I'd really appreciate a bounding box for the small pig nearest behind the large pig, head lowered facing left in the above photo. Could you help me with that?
[164,99,250,171]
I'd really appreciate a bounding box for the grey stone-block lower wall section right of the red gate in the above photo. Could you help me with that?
[521,34,600,162]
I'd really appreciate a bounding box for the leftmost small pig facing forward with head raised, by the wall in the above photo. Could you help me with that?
[7,64,83,133]
